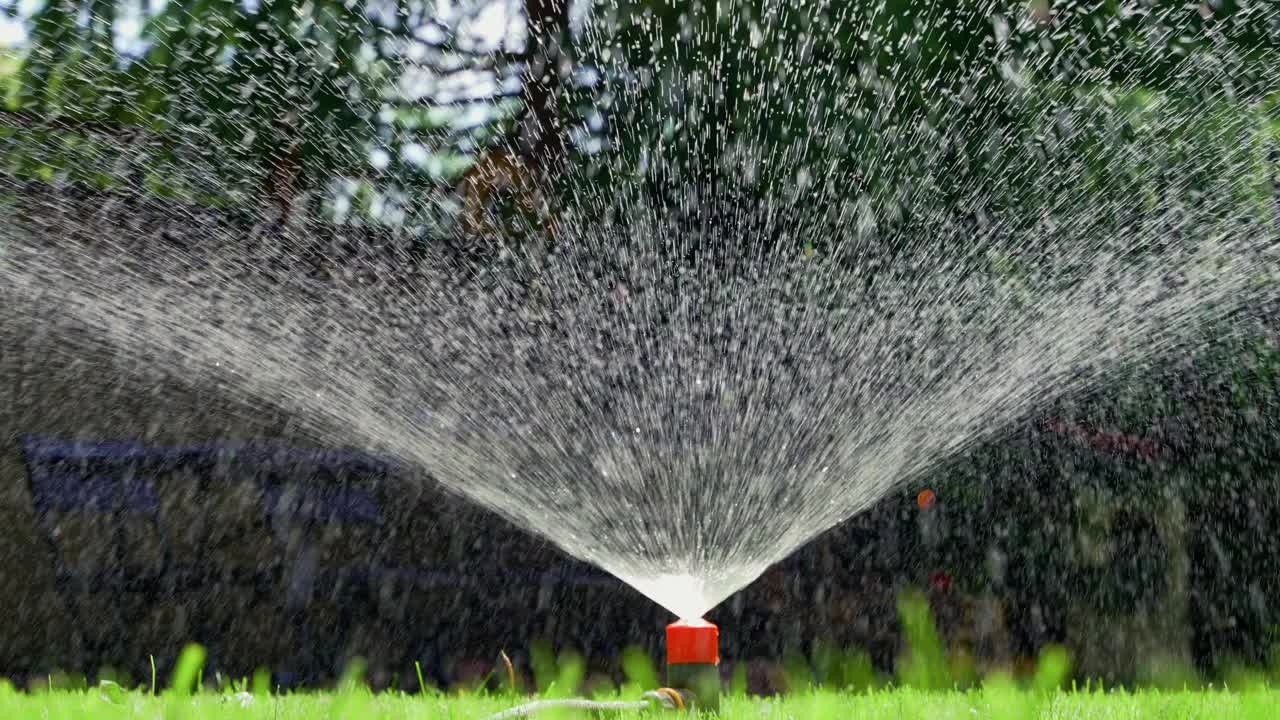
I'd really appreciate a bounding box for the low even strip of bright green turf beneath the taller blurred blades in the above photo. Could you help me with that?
[0,683,1280,720]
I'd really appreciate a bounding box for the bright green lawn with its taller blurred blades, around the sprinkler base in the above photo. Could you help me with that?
[10,593,1280,720]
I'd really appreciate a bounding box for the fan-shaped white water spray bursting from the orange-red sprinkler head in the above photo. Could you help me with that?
[0,3,1280,618]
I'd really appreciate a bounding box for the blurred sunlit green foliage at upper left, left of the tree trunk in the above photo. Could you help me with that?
[0,0,518,224]
